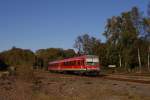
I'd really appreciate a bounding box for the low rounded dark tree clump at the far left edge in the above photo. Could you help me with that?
[0,47,35,66]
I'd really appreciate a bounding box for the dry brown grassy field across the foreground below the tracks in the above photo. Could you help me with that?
[0,70,150,100]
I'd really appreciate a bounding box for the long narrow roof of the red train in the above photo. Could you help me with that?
[49,55,97,64]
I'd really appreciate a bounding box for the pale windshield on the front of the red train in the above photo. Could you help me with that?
[86,56,99,66]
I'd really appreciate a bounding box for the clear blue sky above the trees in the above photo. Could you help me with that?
[0,0,150,51]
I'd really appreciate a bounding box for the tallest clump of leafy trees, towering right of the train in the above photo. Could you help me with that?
[103,7,150,71]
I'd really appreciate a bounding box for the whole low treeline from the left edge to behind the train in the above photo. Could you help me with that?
[0,47,76,69]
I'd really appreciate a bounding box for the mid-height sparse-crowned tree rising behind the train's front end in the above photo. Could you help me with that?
[74,34,108,66]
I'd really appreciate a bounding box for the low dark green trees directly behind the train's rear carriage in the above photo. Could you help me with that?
[35,48,76,68]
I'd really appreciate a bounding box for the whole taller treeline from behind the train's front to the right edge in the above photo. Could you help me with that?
[74,4,150,71]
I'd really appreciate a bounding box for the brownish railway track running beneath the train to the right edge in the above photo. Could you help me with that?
[48,73,150,84]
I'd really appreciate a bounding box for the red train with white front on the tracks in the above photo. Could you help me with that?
[48,55,100,75]
